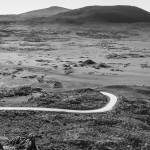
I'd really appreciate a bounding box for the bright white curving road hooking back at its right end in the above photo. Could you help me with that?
[0,92,117,114]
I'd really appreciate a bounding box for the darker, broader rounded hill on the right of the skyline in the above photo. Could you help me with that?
[47,5,150,24]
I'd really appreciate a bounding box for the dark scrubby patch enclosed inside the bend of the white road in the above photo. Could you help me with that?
[29,88,107,110]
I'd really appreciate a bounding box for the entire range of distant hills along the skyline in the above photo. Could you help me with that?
[0,5,150,24]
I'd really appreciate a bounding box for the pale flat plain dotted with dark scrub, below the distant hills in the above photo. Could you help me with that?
[0,24,150,88]
